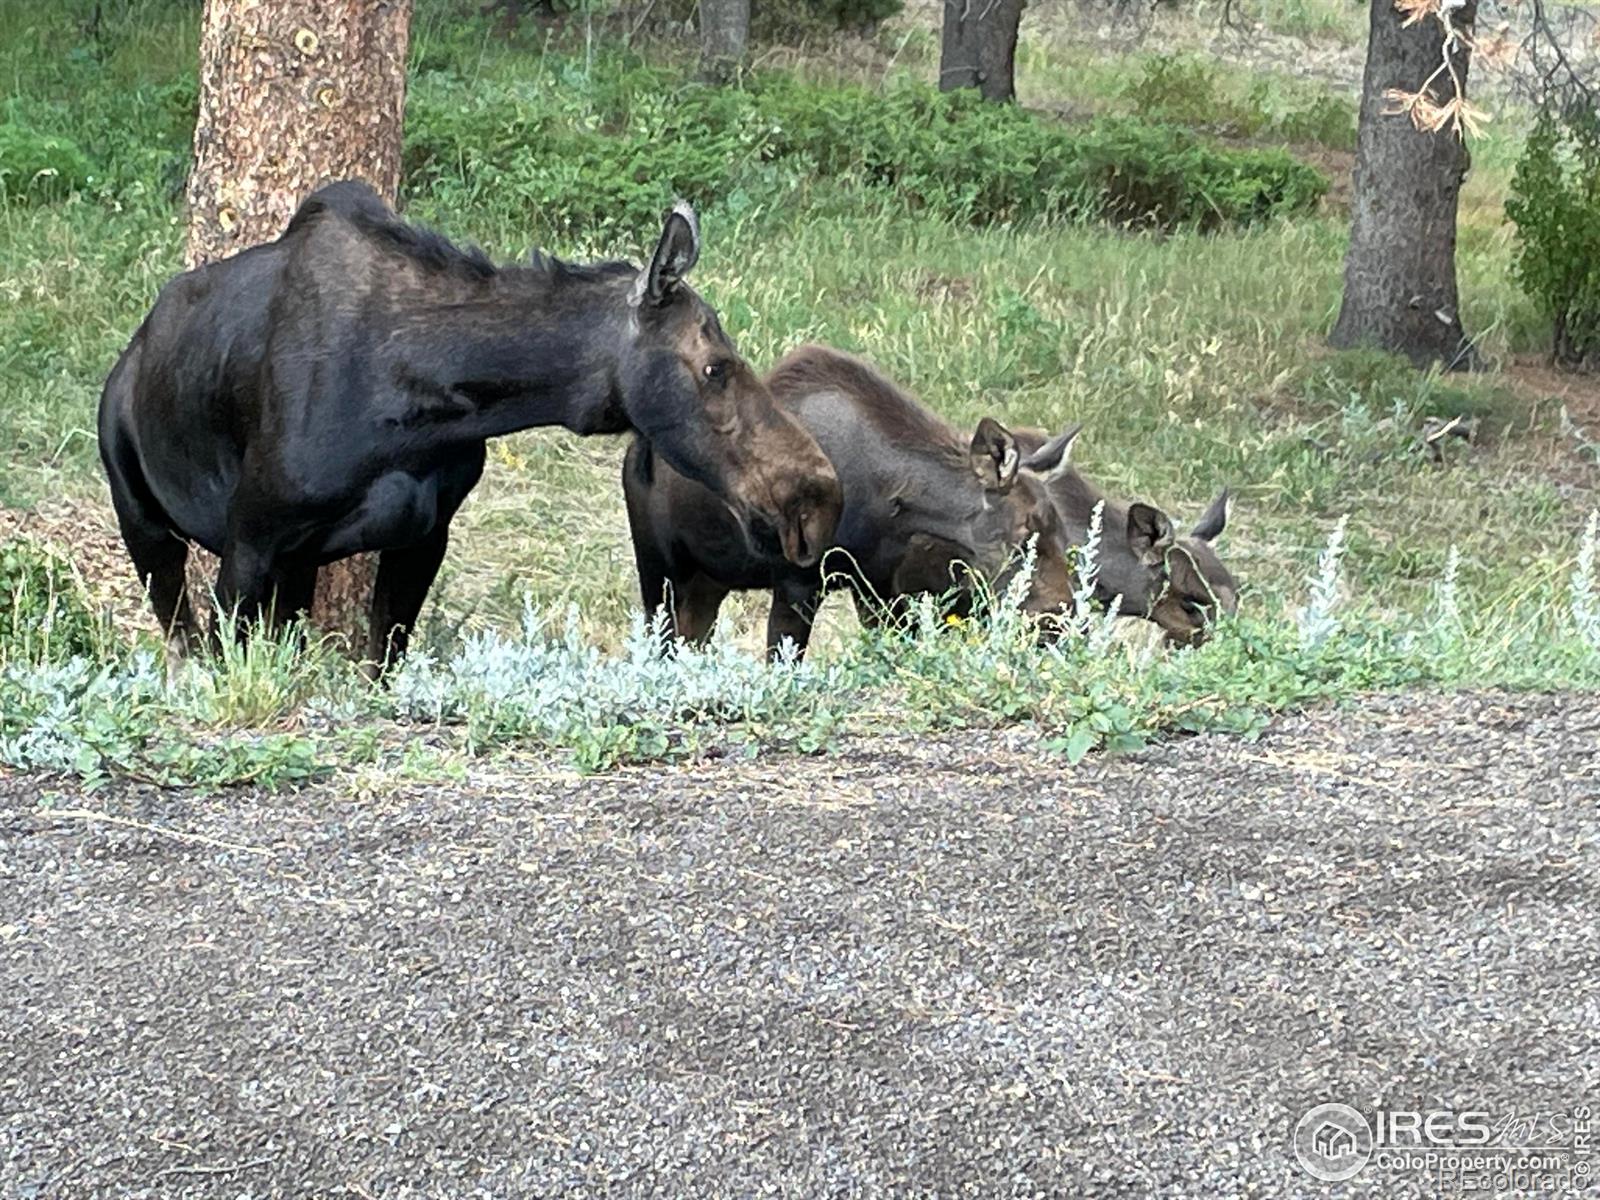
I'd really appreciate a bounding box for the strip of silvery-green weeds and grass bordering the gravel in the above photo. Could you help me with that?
[0,518,1600,787]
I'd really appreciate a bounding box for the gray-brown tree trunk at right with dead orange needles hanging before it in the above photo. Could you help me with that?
[1330,0,1477,368]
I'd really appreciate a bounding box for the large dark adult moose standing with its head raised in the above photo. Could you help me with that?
[99,182,842,666]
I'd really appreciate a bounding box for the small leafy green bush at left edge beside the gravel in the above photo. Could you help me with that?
[0,538,106,664]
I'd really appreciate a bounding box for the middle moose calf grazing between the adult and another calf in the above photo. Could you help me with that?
[622,346,1070,651]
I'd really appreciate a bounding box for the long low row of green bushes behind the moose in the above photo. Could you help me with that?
[405,62,1326,237]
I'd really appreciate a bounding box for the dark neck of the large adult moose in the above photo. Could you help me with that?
[397,269,632,442]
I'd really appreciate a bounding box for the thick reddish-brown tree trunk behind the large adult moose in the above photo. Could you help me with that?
[187,0,411,653]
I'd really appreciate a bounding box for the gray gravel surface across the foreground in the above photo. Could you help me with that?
[0,694,1600,1200]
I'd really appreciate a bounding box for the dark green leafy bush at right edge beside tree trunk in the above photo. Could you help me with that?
[1506,109,1600,370]
